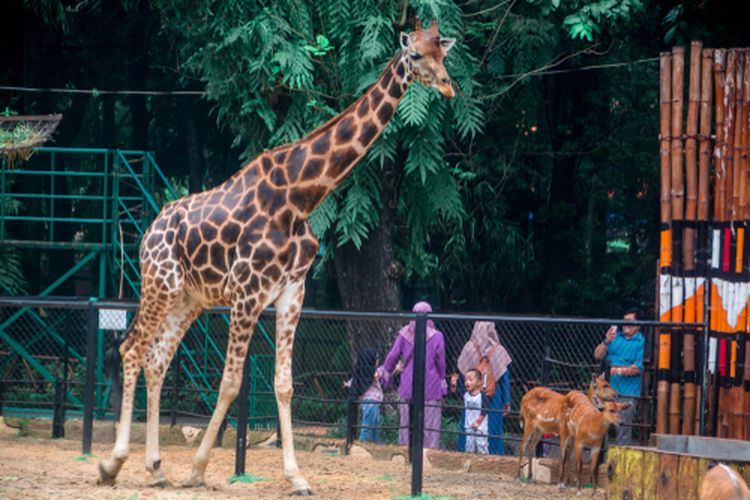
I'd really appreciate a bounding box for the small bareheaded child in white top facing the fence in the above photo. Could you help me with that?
[451,368,489,455]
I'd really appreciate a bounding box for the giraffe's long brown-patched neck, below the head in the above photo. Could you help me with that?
[277,51,414,216]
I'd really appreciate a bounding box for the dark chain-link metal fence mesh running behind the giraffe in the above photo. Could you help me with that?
[0,298,701,494]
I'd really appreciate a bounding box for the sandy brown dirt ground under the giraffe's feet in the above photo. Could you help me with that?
[0,433,603,500]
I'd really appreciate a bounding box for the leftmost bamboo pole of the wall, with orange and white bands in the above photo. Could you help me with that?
[656,48,672,434]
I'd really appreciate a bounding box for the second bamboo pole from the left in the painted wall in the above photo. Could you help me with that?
[669,47,685,434]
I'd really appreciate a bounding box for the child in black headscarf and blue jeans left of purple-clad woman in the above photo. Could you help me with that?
[345,347,389,443]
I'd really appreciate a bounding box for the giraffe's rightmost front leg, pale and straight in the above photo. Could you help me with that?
[274,282,313,496]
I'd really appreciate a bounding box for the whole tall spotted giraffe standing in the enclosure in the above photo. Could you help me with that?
[99,17,455,495]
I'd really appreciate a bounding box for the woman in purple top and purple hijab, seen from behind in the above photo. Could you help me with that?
[383,302,448,448]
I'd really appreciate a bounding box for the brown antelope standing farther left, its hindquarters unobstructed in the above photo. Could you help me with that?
[516,375,617,487]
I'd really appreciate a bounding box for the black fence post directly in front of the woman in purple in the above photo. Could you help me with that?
[411,313,427,497]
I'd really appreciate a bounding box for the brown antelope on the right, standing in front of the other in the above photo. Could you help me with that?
[560,392,632,495]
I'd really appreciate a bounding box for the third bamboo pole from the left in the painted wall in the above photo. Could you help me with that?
[682,42,703,434]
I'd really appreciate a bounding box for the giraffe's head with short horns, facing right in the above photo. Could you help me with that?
[400,20,456,98]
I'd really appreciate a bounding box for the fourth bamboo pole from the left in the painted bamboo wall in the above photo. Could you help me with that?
[686,49,714,434]
